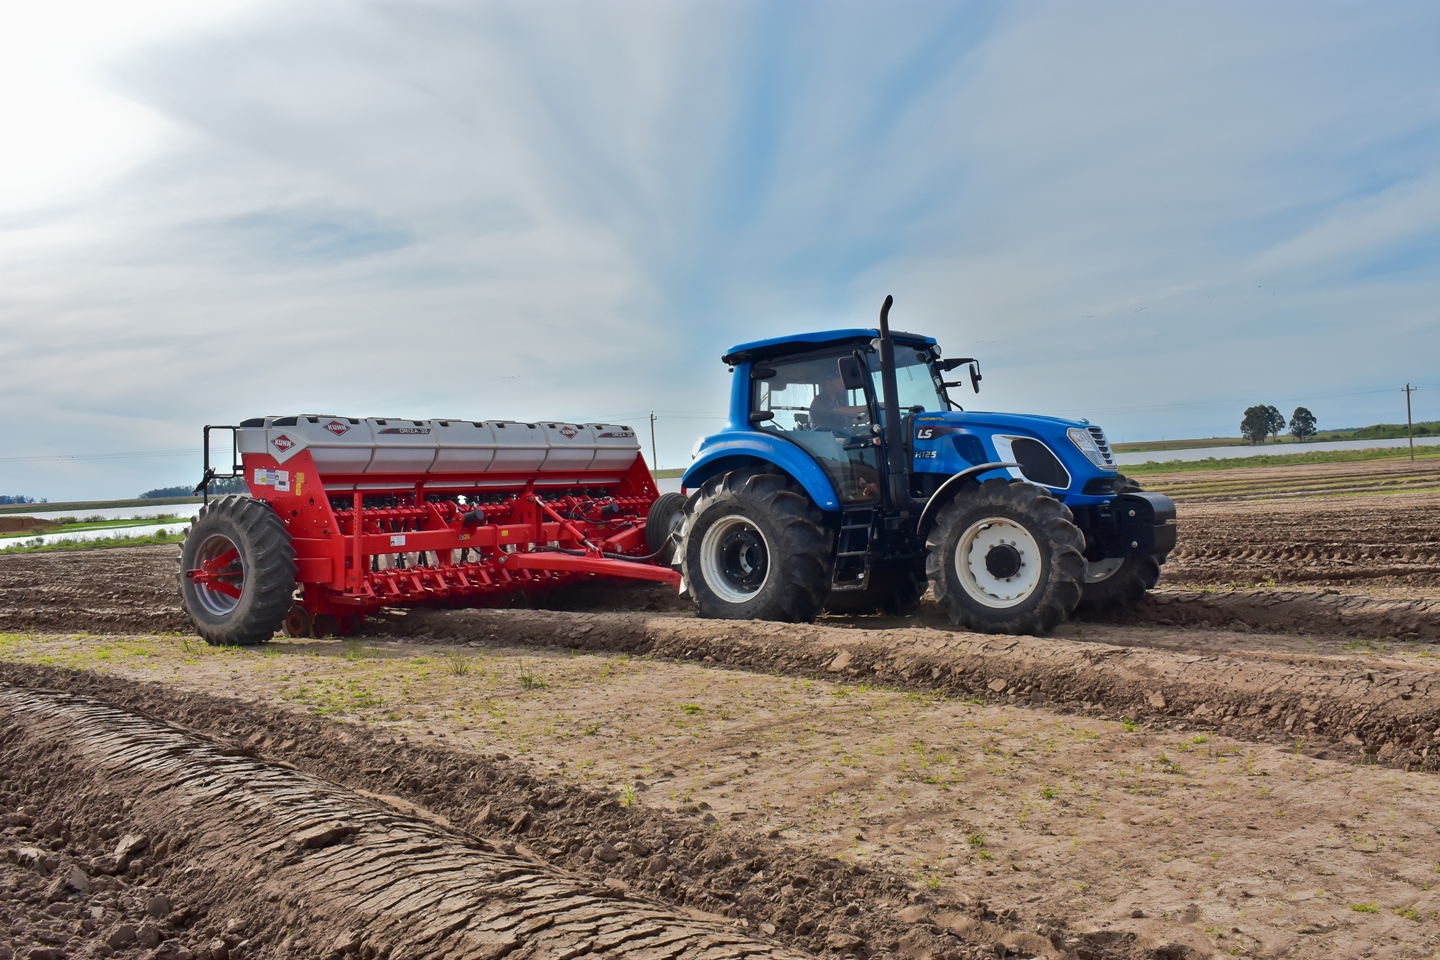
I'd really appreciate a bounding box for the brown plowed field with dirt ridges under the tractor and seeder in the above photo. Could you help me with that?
[0,465,1440,960]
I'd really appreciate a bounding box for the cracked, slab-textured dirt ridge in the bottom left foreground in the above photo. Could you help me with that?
[0,688,798,960]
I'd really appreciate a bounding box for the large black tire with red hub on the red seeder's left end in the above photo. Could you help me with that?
[179,495,295,646]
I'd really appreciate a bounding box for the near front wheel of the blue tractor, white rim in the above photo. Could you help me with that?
[926,479,1086,633]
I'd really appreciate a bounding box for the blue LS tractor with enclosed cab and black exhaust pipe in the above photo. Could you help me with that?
[668,296,1175,633]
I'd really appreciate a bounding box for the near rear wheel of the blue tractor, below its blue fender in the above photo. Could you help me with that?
[680,469,832,623]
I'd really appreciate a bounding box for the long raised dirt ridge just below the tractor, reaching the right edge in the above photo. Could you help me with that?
[400,610,1440,770]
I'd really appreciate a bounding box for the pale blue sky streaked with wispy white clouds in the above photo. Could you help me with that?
[0,0,1440,501]
